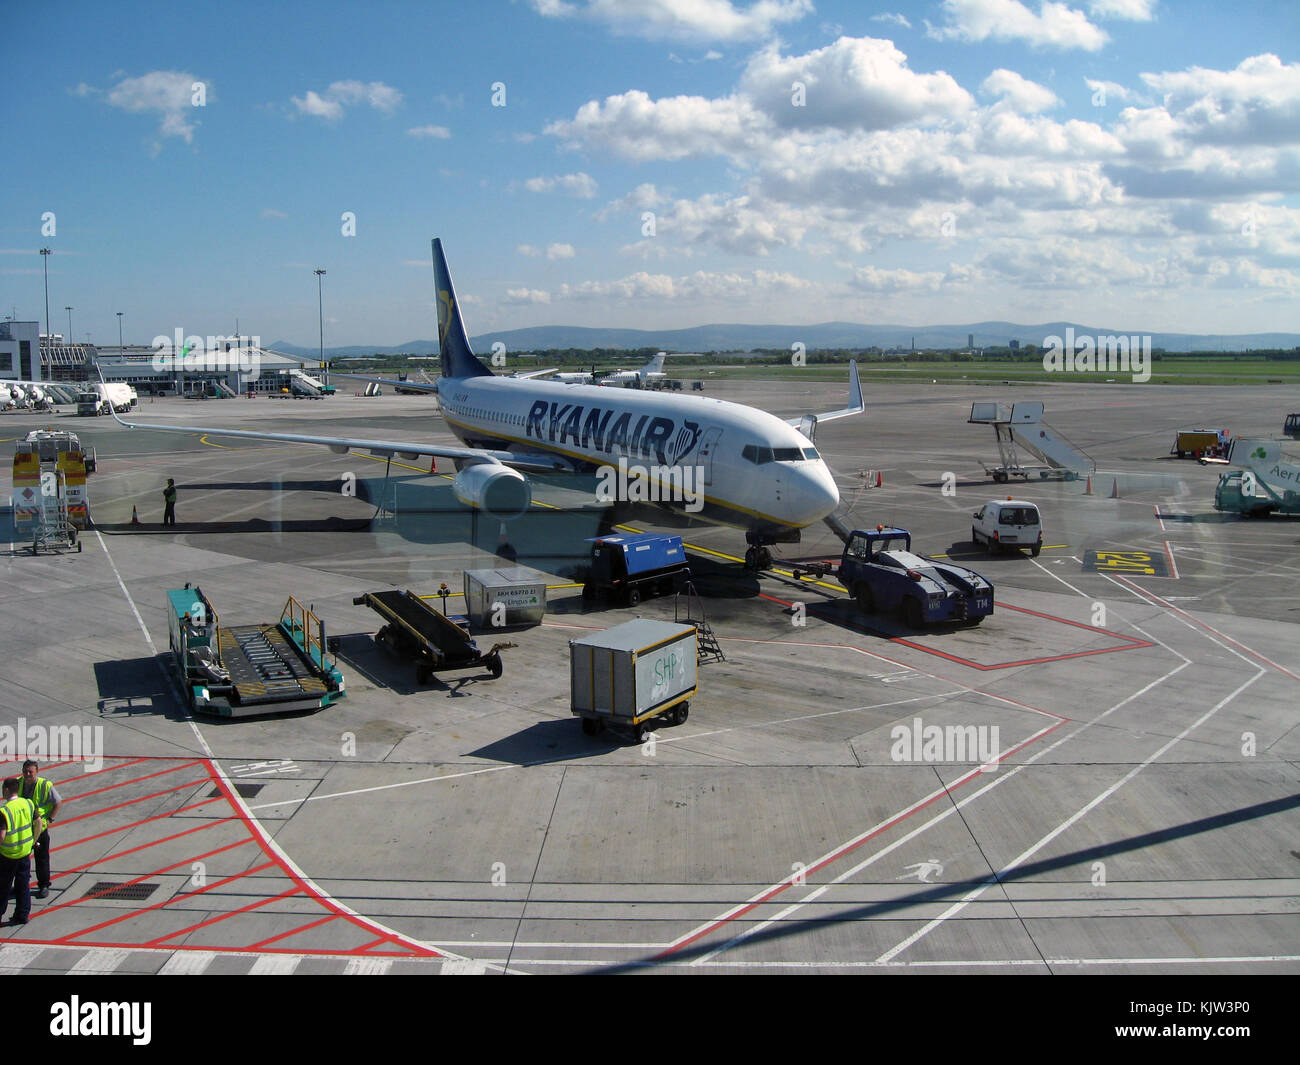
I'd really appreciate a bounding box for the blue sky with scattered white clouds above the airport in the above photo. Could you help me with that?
[0,0,1300,345]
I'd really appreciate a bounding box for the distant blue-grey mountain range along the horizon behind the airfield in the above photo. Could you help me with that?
[272,321,1300,359]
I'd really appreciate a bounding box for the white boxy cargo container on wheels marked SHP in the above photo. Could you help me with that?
[569,618,699,743]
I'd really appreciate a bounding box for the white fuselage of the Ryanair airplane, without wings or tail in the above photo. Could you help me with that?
[438,377,840,529]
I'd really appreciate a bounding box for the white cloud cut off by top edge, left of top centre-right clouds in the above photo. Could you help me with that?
[532,0,813,42]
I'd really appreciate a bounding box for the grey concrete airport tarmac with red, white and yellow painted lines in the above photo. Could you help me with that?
[0,376,1300,974]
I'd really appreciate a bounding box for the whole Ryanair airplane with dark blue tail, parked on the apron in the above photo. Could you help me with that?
[114,238,863,566]
